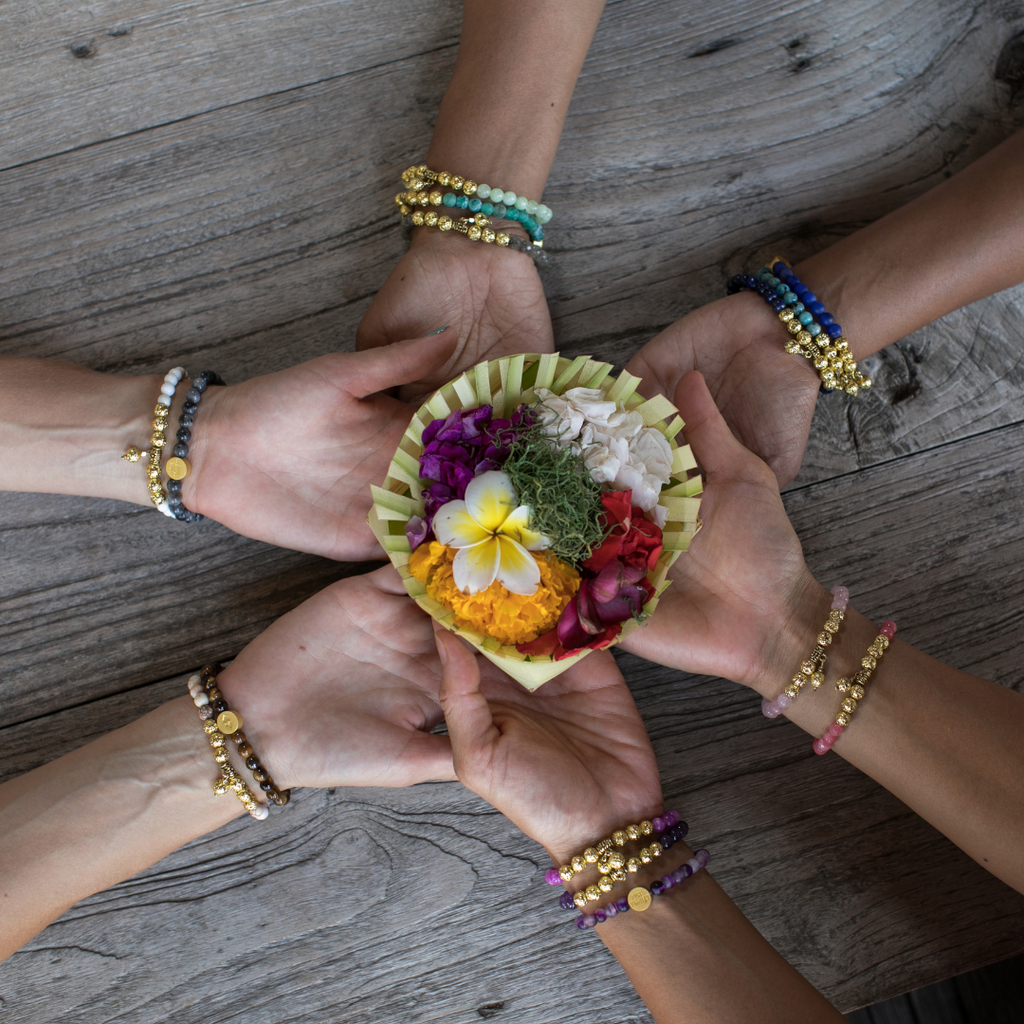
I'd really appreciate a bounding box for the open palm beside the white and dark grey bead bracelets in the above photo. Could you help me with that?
[182,332,455,561]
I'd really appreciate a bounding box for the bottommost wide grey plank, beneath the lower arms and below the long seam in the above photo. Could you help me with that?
[0,426,1024,1024]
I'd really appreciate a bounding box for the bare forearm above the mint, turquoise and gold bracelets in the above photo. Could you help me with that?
[427,0,604,194]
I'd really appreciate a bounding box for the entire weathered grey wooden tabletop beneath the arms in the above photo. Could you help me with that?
[0,0,1024,1024]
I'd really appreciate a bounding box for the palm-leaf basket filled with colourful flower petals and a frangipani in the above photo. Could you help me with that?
[369,354,701,689]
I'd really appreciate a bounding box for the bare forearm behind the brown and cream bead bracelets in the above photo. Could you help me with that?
[0,697,243,959]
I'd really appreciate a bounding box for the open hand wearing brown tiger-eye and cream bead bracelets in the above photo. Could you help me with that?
[217,565,455,788]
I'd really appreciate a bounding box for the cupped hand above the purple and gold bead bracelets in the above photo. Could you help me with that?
[436,628,664,863]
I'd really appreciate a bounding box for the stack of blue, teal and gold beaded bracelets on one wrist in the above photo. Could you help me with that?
[726,258,871,395]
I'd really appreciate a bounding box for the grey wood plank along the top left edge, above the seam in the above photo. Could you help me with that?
[0,0,460,167]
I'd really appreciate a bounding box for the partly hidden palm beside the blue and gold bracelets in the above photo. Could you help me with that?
[626,292,820,486]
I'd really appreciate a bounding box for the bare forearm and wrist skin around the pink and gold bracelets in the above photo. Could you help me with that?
[762,595,1024,892]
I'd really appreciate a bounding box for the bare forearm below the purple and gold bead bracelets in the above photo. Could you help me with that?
[596,845,843,1024]
